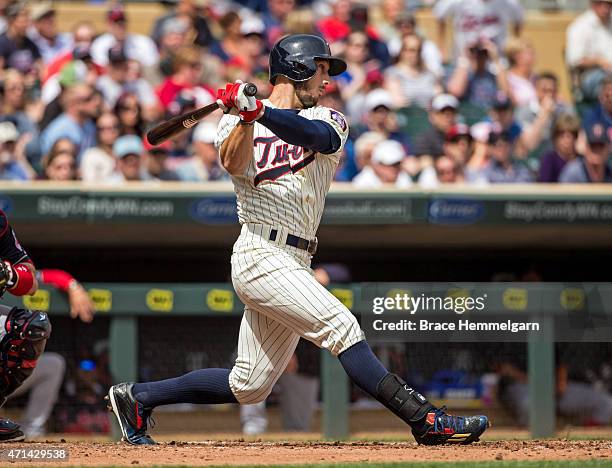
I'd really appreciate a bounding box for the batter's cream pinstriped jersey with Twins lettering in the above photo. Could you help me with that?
[215,100,348,239]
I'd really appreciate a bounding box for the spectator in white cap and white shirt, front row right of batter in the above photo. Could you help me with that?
[353,140,412,189]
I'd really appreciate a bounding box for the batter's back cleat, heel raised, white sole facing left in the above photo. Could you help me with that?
[104,383,156,445]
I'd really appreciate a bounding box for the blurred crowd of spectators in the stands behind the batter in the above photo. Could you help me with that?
[0,0,612,188]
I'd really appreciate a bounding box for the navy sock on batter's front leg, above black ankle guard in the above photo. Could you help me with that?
[338,341,389,398]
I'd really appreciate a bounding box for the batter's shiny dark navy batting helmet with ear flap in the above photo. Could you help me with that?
[270,34,346,84]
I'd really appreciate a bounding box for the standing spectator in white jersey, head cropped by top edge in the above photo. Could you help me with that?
[433,0,524,61]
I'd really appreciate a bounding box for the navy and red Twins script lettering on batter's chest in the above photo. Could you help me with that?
[253,136,314,186]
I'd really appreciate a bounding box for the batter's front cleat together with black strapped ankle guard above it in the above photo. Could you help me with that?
[377,374,489,445]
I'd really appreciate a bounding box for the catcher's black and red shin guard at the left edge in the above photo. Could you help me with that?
[0,307,51,402]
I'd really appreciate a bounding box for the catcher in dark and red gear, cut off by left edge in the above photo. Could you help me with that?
[0,211,51,442]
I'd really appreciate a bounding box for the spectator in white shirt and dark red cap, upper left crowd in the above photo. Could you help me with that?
[91,6,159,67]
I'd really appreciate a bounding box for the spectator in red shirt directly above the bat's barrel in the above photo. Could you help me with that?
[155,47,214,111]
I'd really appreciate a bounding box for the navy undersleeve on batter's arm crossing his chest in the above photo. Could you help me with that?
[258,107,341,154]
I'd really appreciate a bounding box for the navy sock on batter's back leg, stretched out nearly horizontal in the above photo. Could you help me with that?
[132,369,238,408]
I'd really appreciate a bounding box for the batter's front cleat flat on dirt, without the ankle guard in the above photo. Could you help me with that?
[412,406,490,445]
